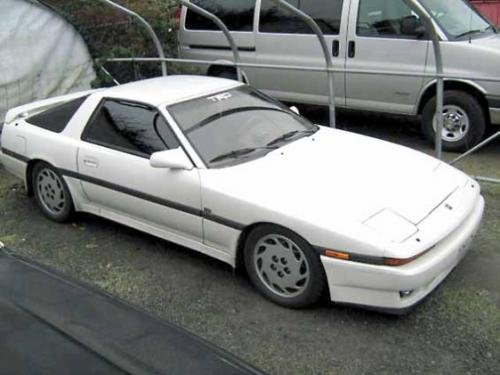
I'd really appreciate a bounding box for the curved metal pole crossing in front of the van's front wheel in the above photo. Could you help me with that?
[407,0,444,159]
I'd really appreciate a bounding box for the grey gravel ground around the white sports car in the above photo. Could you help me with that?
[0,110,500,374]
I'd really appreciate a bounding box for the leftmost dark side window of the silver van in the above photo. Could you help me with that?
[186,0,255,31]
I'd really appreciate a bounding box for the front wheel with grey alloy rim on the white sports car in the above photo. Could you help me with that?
[244,224,325,308]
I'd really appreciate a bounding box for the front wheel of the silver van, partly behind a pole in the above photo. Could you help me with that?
[422,90,486,152]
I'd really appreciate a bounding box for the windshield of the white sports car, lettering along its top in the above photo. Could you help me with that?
[167,86,318,167]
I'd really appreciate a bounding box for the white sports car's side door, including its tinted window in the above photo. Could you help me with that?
[77,99,202,241]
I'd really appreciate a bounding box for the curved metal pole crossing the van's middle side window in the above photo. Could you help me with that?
[271,0,336,128]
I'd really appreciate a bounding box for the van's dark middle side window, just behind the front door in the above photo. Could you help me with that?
[259,0,343,35]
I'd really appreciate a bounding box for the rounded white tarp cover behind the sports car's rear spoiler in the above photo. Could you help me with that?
[0,0,95,122]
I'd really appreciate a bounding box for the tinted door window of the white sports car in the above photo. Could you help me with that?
[83,100,179,157]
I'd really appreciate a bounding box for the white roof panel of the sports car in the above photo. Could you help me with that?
[99,75,242,107]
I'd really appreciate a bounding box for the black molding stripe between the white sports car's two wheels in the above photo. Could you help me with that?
[58,169,245,230]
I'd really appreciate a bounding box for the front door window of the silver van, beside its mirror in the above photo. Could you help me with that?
[356,0,419,39]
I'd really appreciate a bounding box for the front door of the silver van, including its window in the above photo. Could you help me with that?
[346,0,431,114]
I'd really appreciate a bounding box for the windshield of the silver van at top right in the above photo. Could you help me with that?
[420,0,496,39]
